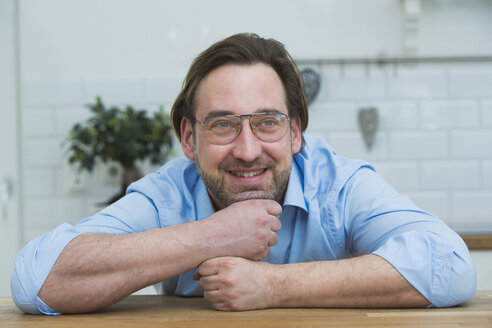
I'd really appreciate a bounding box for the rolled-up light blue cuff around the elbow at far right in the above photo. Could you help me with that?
[373,231,476,307]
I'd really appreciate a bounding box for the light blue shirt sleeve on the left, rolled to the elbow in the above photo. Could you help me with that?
[10,192,160,315]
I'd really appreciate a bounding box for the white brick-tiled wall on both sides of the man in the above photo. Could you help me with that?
[22,64,492,241]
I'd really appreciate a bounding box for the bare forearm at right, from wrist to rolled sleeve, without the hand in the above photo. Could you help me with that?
[270,255,429,308]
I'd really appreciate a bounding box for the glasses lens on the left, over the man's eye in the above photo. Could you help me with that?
[204,116,241,145]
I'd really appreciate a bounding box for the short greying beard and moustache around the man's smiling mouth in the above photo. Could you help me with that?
[194,148,292,209]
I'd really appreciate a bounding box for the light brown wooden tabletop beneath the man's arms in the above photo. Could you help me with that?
[0,291,492,328]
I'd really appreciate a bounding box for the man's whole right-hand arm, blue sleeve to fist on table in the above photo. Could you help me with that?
[195,170,476,309]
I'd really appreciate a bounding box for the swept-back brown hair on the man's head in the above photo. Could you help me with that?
[171,33,308,140]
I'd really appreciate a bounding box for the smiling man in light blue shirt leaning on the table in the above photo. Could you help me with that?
[12,34,475,314]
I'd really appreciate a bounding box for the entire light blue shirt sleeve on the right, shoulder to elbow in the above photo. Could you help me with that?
[339,169,476,307]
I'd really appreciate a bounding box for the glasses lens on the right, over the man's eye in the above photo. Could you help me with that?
[251,113,289,142]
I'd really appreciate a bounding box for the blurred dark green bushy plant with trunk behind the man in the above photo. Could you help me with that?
[66,97,173,204]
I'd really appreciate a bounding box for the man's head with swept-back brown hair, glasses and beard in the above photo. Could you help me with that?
[171,34,307,208]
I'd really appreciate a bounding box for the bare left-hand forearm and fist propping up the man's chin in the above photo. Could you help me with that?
[17,200,281,313]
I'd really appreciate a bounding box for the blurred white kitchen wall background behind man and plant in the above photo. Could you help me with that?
[0,0,492,296]
